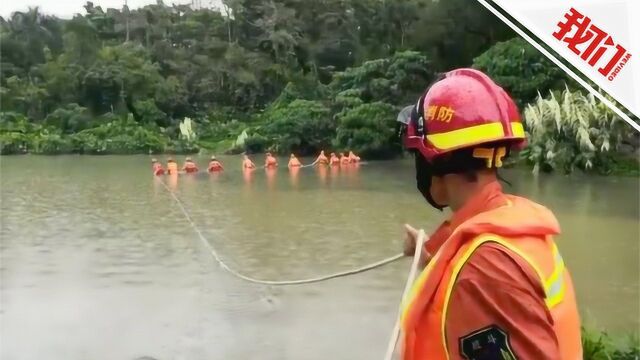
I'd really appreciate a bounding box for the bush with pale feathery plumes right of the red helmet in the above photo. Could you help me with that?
[521,89,627,174]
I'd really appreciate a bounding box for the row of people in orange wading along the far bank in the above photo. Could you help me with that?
[151,150,360,175]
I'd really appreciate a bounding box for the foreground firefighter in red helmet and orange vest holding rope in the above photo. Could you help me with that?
[399,69,582,360]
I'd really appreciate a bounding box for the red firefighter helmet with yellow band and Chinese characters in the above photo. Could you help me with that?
[399,69,526,162]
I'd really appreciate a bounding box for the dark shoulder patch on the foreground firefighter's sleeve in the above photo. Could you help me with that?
[458,325,517,360]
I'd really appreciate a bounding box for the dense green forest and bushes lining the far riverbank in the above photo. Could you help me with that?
[0,0,629,173]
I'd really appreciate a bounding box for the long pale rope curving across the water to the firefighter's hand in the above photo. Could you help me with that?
[160,180,404,286]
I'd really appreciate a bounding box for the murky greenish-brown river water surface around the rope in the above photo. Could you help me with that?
[0,156,640,360]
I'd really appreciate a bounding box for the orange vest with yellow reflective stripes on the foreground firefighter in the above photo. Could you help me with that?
[401,195,582,360]
